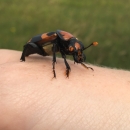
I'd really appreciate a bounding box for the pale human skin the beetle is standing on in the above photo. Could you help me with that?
[0,49,130,130]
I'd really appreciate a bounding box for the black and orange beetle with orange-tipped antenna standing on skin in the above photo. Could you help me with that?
[20,30,98,78]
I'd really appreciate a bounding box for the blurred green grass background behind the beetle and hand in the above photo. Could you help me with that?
[0,0,130,70]
